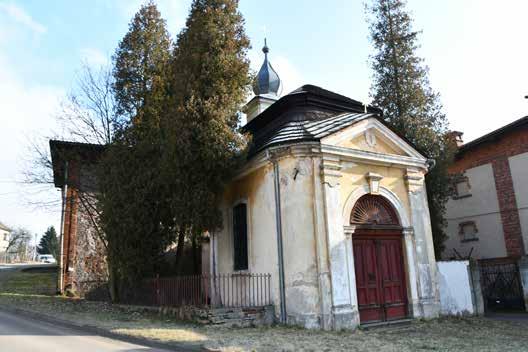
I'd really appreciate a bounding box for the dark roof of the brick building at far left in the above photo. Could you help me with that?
[50,139,105,187]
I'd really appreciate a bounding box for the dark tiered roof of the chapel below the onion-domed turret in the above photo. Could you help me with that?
[242,85,427,157]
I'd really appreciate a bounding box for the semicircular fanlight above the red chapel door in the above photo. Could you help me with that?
[350,194,399,226]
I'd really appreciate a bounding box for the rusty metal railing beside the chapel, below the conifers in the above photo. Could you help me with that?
[124,273,272,308]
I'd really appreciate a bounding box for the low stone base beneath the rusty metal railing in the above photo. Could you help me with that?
[155,306,275,327]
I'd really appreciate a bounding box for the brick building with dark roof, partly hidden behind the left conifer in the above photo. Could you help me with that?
[50,140,107,296]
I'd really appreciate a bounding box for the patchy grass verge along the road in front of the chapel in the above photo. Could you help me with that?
[0,273,528,352]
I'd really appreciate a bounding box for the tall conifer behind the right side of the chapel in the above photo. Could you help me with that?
[369,0,452,256]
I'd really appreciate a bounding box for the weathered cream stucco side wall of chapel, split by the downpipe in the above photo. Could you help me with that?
[216,156,320,328]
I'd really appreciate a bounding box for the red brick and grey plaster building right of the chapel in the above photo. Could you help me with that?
[443,116,528,262]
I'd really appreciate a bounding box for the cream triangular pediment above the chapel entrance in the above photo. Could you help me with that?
[321,117,425,159]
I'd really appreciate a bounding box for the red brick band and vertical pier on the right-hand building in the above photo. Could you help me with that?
[449,128,528,257]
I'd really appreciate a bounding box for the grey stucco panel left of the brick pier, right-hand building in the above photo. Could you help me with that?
[442,164,507,259]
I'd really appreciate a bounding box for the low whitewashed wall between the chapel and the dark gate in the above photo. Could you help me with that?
[437,260,475,315]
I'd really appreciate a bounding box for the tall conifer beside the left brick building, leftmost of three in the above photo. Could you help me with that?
[98,2,173,300]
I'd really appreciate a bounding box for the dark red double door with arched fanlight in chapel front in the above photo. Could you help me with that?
[350,194,407,323]
